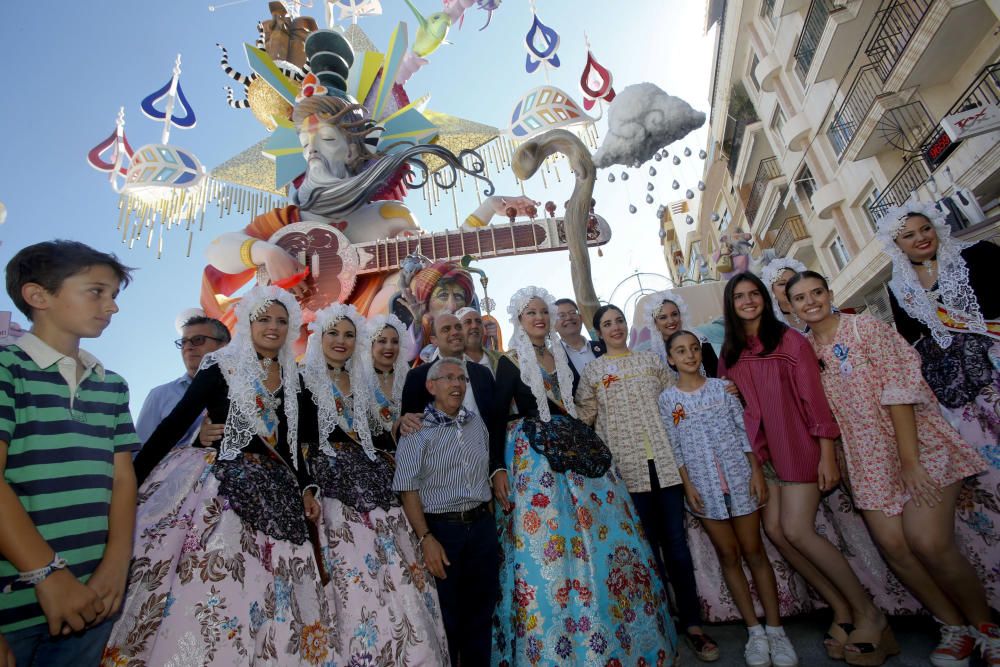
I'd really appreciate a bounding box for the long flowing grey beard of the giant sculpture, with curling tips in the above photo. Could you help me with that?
[292,144,493,218]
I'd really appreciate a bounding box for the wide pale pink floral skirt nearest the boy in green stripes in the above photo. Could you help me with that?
[102,447,334,667]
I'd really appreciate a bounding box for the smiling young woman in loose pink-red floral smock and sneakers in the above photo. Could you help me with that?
[787,271,1000,666]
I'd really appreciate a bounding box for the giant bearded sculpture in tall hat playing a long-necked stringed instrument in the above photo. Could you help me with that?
[201,30,610,354]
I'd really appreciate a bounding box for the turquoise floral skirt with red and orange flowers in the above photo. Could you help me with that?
[493,416,677,667]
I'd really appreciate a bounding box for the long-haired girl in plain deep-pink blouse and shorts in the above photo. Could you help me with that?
[719,272,899,665]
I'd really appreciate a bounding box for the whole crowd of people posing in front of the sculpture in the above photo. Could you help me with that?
[0,200,1000,667]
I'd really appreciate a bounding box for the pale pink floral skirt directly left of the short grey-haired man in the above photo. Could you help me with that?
[321,488,449,667]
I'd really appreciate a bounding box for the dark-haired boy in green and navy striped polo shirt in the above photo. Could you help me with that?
[0,241,139,667]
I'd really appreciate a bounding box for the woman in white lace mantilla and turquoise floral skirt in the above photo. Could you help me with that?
[493,287,676,667]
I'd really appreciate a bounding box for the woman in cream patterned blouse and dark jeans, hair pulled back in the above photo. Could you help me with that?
[576,304,719,661]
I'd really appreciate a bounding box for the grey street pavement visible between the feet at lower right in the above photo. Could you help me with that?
[681,612,938,667]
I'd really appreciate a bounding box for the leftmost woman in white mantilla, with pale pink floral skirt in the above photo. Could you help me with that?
[104,287,334,667]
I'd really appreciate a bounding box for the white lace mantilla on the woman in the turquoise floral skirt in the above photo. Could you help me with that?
[507,286,577,422]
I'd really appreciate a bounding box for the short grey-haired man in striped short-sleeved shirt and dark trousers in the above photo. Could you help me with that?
[392,357,499,666]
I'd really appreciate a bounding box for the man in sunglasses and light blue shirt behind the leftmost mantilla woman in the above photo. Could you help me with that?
[135,310,229,445]
